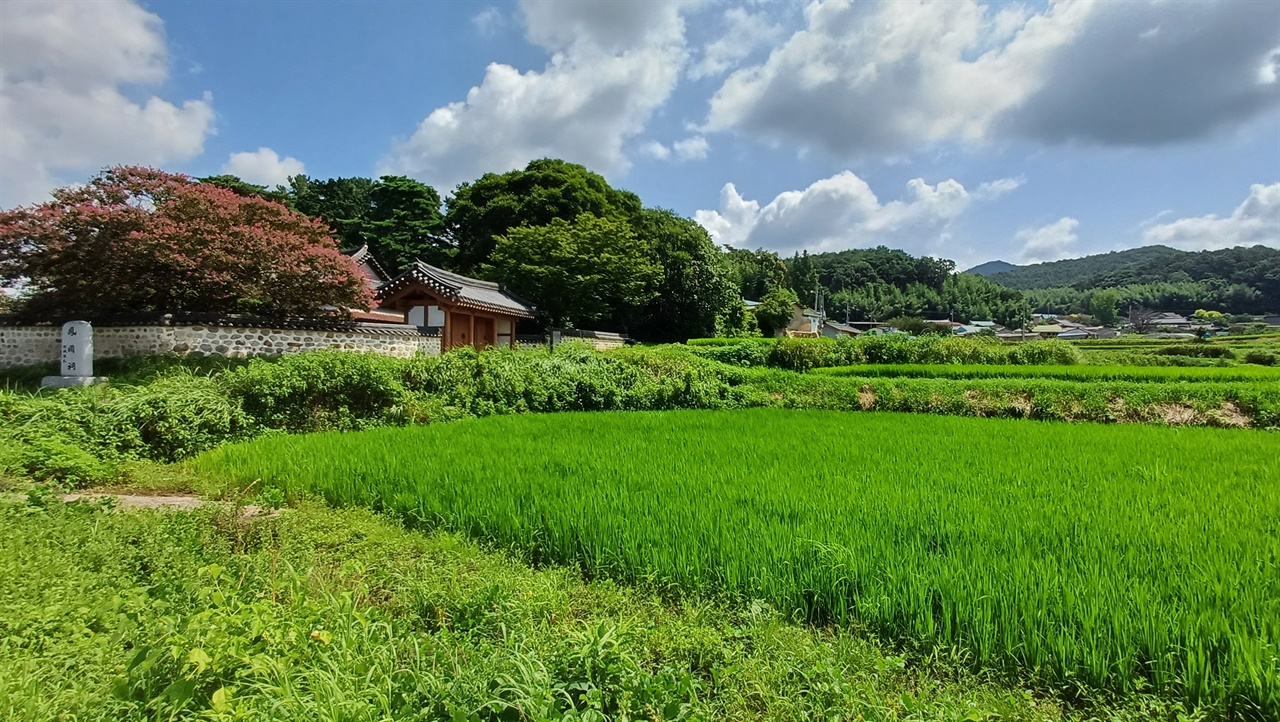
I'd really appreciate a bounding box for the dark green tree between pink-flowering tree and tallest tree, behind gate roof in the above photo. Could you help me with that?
[355,175,451,273]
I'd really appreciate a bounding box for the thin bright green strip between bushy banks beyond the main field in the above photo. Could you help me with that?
[814,364,1280,383]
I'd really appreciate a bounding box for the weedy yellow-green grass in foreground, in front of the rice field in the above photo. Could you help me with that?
[0,494,1177,722]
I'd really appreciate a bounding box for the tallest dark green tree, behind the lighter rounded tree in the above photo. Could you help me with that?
[445,159,640,273]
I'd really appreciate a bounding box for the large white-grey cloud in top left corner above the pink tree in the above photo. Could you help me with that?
[0,0,214,207]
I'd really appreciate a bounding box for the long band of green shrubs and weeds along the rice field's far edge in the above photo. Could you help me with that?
[0,337,1280,486]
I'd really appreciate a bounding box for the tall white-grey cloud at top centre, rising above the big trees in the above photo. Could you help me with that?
[379,0,687,188]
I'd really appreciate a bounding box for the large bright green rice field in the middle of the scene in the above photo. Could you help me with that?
[195,410,1280,719]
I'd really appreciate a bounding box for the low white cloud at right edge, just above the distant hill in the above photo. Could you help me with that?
[1143,183,1280,251]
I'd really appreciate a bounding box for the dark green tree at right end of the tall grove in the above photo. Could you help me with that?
[634,209,745,341]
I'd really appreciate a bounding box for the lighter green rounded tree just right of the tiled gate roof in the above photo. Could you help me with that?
[490,214,662,325]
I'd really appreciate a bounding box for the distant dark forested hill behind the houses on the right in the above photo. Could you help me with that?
[969,246,1280,291]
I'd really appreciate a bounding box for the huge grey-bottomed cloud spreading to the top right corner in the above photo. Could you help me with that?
[705,0,1280,154]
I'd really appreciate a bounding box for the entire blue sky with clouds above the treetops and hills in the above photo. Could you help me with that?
[0,0,1280,269]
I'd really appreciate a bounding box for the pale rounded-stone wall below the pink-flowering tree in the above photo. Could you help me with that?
[0,324,440,367]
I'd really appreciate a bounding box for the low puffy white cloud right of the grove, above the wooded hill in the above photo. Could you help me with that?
[694,170,1016,253]
